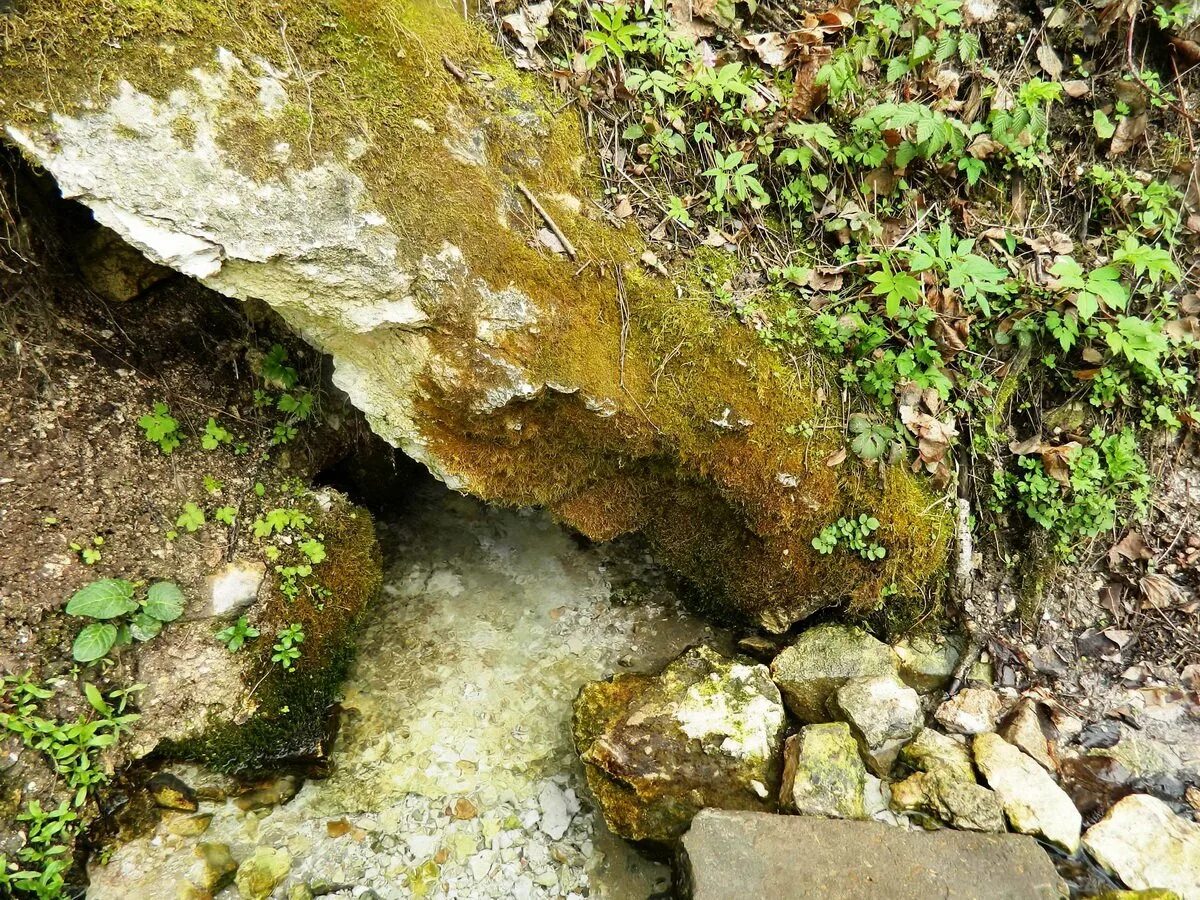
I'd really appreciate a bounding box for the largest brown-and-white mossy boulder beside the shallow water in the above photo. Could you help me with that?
[574,646,785,842]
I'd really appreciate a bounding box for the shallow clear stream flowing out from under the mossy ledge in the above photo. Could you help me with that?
[89,482,714,900]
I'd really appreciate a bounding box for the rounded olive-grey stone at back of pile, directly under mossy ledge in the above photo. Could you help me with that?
[770,625,896,722]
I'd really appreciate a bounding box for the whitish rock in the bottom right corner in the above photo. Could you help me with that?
[1084,793,1200,900]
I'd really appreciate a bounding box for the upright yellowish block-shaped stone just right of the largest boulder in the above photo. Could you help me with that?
[780,722,866,818]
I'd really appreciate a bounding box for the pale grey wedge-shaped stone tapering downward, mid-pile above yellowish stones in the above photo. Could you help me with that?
[830,672,924,776]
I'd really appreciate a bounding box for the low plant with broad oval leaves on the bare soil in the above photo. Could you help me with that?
[66,578,185,662]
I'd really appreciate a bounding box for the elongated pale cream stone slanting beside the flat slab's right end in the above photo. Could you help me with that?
[974,734,1082,853]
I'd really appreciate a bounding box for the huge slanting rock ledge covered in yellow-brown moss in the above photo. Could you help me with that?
[0,0,948,630]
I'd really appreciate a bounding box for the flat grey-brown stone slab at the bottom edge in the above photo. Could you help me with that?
[680,810,1067,900]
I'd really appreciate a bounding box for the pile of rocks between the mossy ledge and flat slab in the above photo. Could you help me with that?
[576,624,1200,896]
